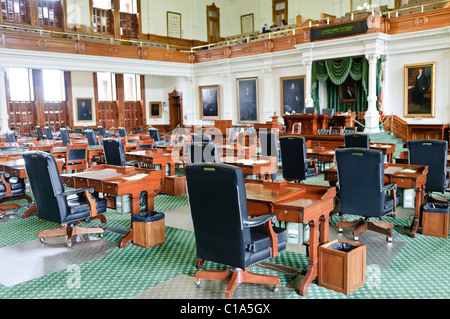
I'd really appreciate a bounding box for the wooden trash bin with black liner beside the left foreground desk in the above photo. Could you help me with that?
[132,212,166,248]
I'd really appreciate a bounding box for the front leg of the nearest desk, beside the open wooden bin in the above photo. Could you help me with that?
[299,221,321,296]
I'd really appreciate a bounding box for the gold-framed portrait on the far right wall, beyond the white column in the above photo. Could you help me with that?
[404,62,436,117]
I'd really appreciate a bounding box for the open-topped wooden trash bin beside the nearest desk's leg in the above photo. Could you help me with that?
[318,239,366,295]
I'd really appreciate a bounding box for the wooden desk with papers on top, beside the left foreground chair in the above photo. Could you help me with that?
[61,165,161,248]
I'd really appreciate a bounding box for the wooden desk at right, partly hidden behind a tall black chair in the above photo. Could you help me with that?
[324,163,428,238]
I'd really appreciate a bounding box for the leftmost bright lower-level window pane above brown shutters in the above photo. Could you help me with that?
[8,68,34,102]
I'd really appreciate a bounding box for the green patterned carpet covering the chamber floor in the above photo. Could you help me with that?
[0,185,450,299]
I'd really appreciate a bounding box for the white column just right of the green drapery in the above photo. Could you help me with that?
[364,54,380,133]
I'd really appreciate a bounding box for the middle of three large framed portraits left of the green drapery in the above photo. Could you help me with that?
[237,78,258,123]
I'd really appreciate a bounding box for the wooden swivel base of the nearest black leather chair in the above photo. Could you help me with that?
[195,259,281,299]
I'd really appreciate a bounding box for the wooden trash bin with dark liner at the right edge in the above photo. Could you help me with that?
[422,202,448,238]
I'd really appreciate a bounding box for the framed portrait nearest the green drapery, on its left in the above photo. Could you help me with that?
[280,76,305,115]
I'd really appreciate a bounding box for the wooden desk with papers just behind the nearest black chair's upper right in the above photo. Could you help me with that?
[220,156,277,179]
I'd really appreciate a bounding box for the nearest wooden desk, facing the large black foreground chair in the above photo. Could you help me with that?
[245,179,336,296]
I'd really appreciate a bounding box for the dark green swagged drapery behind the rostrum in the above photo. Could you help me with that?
[311,57,381,116]
